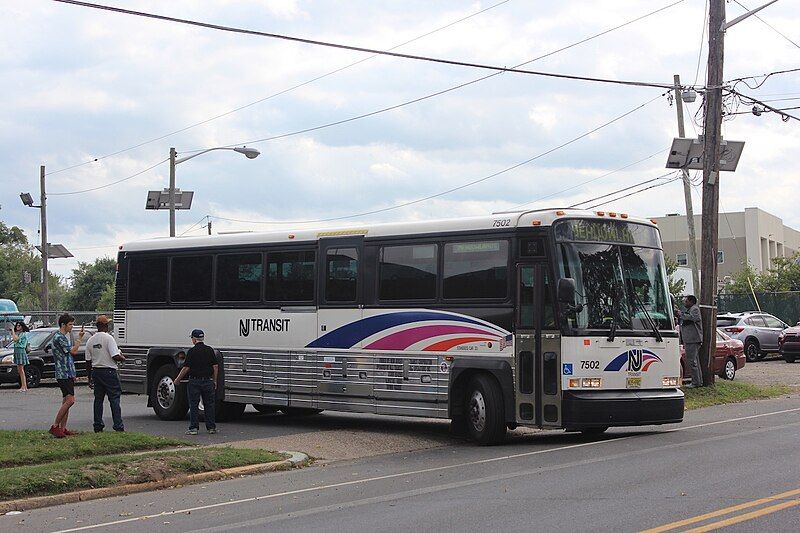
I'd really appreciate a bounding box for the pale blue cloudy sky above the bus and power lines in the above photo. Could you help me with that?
[0,0,800,280]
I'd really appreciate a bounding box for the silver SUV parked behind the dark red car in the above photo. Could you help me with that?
[717,311,789,363]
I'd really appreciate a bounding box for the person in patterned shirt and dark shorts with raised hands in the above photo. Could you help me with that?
[50,313,86,439]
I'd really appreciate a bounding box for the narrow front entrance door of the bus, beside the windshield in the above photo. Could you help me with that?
[514,262,561,427]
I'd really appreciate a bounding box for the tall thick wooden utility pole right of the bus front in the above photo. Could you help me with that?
[700,0,725,386]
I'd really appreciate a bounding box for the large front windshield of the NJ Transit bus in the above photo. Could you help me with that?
[559,243,673,331]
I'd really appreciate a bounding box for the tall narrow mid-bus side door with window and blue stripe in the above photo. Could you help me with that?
[314,236,375,412]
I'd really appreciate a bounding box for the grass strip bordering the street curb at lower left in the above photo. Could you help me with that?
[0,446,282,500]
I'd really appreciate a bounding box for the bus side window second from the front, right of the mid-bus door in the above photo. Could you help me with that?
[379,244,437,300]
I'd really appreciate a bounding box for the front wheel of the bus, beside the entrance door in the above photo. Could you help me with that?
[465,374,506,446]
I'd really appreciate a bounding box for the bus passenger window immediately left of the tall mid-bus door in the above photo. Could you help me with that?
[266,250,315,302]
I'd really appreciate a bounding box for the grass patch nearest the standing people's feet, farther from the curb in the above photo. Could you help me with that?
[0,430,189,468]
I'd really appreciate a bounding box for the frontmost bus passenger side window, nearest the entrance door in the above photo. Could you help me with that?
[444,241,508,299]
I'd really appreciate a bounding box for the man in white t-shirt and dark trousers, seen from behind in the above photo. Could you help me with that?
[86,315,125,433]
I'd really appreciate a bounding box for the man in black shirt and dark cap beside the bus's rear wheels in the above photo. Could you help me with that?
[175,329,219,435]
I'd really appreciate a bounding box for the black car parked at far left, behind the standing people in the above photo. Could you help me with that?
[0,326,97,388]
